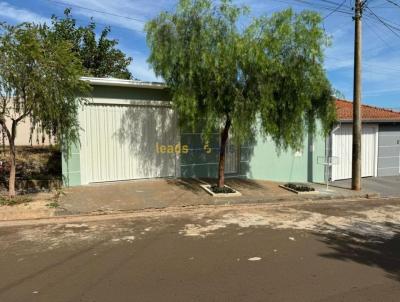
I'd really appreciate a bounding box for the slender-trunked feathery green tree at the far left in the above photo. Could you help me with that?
[0,23,89,197]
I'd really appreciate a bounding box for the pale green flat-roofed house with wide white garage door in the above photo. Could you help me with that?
[63,78,326,186]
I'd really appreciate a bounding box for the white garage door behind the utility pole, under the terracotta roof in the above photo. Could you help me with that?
[332,125,378,180]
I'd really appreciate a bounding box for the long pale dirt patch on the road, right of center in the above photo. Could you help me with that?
[179,205,400,242]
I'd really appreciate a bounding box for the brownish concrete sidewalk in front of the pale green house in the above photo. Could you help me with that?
[57,179,378,215]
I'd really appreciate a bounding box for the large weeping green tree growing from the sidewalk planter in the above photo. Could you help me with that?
[146,0,335,187]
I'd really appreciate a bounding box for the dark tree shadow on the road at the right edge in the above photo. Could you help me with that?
[319,223,400,281]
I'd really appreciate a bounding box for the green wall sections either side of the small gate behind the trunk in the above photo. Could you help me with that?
[181,123,325,182]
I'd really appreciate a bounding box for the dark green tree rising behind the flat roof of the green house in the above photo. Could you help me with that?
[51,9,132,79]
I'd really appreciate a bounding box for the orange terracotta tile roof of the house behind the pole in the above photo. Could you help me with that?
[336,99,400,121]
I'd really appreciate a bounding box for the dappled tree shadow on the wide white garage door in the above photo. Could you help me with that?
[113,105,178,179]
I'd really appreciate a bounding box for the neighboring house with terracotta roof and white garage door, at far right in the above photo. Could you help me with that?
[328,100,400,180]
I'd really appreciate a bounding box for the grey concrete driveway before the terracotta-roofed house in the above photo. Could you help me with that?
[331,176,400,197]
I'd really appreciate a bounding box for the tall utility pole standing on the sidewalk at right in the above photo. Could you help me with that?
[351,0,365,191]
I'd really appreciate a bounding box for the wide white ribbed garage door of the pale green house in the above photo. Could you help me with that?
[80,104,178,184]
